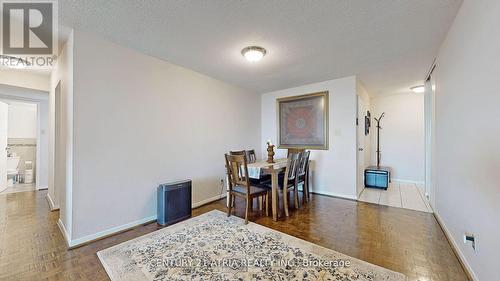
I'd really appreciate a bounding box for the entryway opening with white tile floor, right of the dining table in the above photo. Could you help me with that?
[358,87,433,212]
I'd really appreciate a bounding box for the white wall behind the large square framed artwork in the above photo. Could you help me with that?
[260,76,357,199]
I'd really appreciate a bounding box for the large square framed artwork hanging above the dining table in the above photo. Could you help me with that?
[276,92,329,150]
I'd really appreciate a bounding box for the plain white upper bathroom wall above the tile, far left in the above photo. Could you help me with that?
[7,102,38,139]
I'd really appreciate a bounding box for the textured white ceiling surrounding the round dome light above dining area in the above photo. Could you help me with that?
[59,0,462,95]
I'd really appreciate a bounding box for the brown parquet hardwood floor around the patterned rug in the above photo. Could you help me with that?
[0,191,467,281]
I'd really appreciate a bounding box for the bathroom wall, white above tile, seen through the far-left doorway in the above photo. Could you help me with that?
[7,102,38,181]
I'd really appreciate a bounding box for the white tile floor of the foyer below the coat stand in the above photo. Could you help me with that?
[359,182,433,213]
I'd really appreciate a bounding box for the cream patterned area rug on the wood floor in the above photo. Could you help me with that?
[97,210,407,281]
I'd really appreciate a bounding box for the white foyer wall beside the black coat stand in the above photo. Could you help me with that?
[371,93,425,183]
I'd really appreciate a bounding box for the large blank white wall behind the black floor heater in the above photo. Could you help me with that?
[71,31,260,241]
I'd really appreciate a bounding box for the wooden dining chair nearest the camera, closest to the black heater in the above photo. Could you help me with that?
[225,154,269,224]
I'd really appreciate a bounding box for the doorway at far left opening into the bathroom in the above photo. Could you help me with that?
[0,81,49,195]
